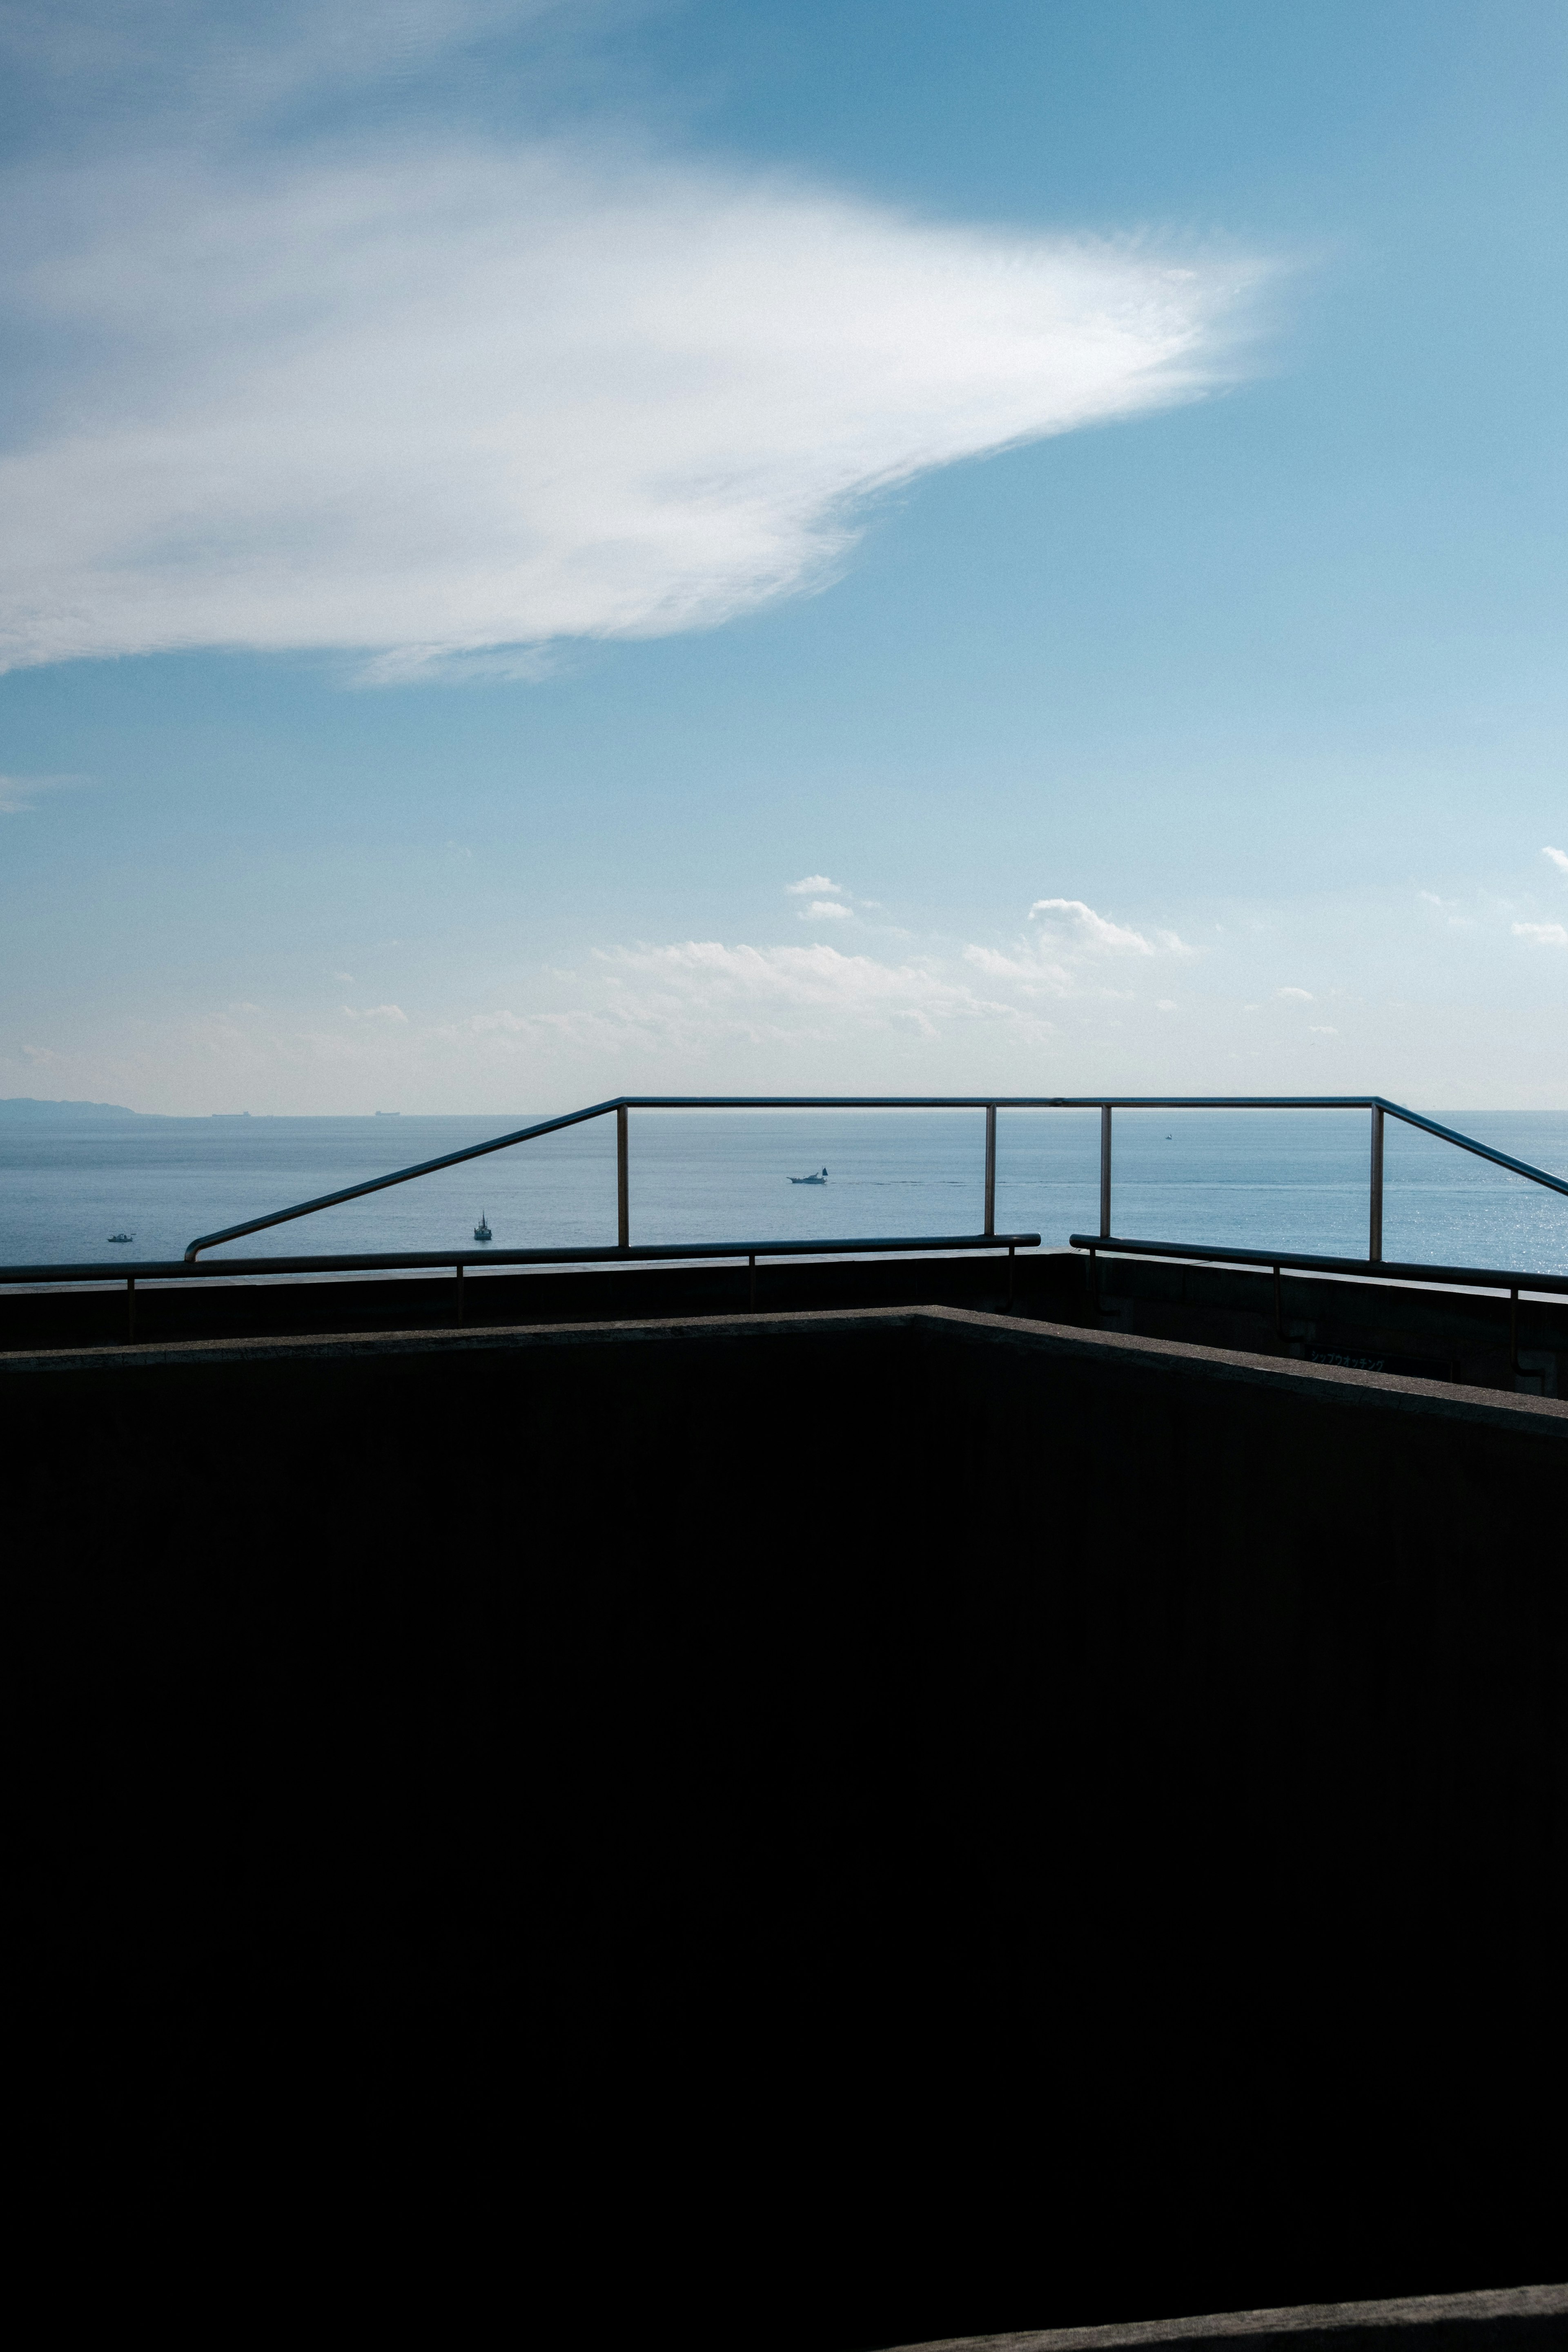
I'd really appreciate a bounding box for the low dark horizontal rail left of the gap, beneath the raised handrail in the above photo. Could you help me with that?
[0,1232,1039,1282]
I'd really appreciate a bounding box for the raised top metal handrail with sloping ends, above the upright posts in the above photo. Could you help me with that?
[172,1094,1568,1265]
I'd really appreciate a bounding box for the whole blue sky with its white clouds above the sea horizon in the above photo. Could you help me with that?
[0,0,1568,1112]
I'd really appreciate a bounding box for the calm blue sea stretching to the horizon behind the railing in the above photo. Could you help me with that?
[0,1110,1568,1272]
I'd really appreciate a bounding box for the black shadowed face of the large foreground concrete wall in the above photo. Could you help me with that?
[0,1310,1568,2352]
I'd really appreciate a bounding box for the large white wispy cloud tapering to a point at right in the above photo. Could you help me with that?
[0,27,1265,682]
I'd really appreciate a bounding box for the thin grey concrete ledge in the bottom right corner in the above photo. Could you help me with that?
[898,2286,1568,2352]
